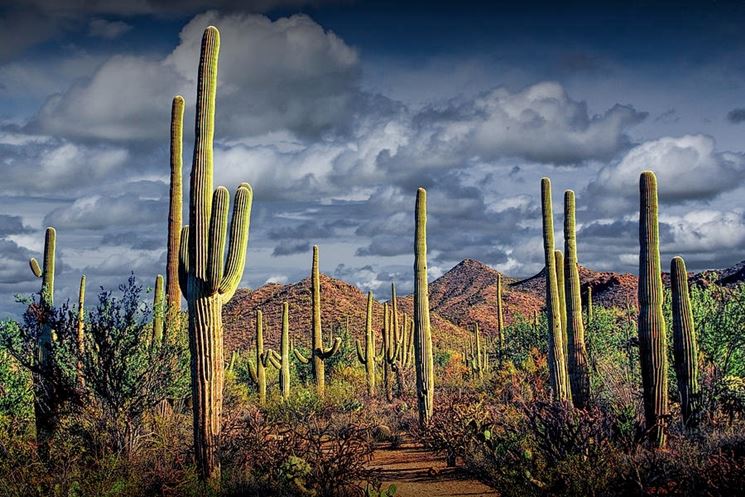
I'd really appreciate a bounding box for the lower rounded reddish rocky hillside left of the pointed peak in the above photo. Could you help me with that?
[223,274,467,351]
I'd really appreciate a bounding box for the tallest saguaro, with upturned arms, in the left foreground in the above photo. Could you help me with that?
[179,26,253,487]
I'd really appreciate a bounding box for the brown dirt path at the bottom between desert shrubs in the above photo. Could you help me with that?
[370,443,499,497]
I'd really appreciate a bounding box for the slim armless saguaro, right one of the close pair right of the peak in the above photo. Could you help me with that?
[564,190,590,408]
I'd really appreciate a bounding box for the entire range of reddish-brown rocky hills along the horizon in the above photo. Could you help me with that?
[223,259,745,351]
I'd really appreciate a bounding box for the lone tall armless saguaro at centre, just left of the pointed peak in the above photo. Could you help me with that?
[414,188,435,426]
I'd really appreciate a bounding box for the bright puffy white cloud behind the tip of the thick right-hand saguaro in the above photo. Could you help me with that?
[588,135,745,211]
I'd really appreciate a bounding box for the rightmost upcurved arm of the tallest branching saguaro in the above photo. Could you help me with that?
[220,183,253,302]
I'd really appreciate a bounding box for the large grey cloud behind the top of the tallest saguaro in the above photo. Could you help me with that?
[30,11,360,141]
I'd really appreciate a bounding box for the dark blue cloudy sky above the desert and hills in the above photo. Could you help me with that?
[0,0,745,316]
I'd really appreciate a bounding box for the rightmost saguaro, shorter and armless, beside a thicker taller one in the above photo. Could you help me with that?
[670,257,701,428]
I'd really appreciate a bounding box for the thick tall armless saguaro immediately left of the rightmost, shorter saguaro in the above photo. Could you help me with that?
[639,171,667,447]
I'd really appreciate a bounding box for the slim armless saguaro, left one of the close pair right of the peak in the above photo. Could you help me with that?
[541,178,571,401]
